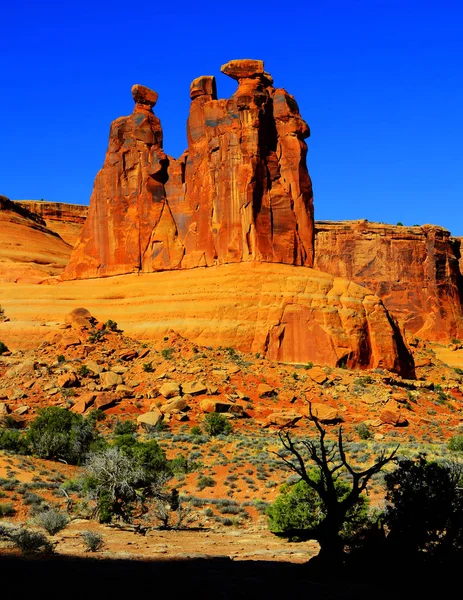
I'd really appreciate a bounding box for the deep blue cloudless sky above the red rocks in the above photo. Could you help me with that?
[0,0,463,235]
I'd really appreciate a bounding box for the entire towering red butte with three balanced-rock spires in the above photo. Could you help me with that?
[63,60,314,279]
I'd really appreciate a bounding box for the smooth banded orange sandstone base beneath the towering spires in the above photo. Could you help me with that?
[0,262,413,377]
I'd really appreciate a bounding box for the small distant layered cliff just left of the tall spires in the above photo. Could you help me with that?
[14,200,88,246]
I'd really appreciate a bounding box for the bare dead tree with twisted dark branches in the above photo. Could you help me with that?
[274,402,399,562]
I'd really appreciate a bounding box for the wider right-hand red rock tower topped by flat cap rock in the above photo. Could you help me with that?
[168,60,313,267]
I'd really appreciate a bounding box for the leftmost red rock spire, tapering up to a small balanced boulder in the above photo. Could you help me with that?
[64,85,183,279]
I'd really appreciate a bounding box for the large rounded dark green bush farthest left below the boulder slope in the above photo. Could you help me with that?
[27,406,97,464]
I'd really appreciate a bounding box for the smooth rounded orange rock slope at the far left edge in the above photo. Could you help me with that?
[0,196,72,283]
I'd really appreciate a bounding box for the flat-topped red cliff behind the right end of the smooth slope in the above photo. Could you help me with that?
[315,221,463,341]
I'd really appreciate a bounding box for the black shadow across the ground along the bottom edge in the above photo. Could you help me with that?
[0,555,461,600]
